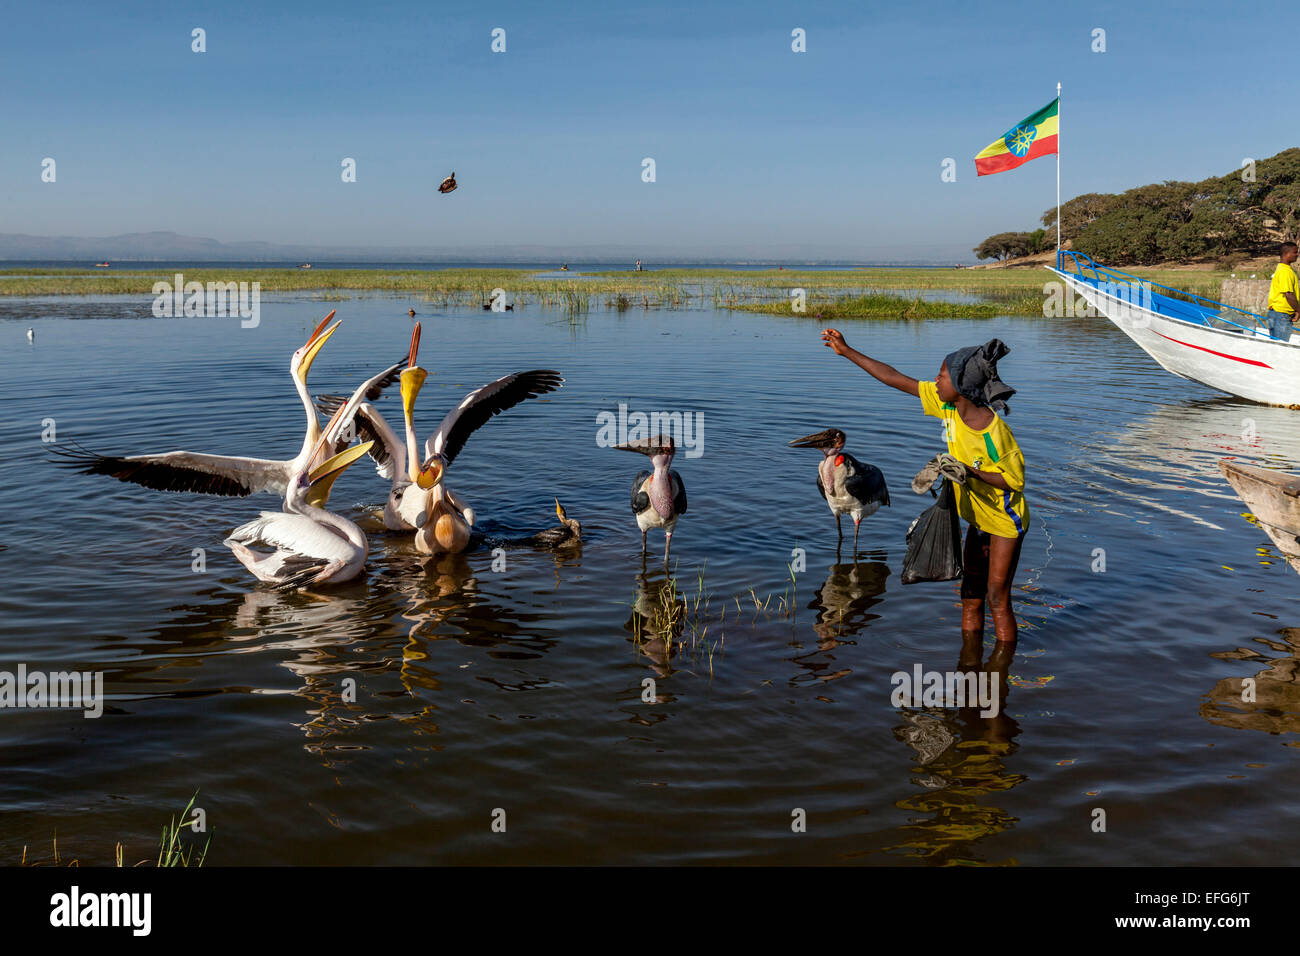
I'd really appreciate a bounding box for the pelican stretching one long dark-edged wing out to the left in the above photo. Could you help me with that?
[51,312,402,505]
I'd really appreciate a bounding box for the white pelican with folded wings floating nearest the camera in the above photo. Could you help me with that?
[224,421,372,589]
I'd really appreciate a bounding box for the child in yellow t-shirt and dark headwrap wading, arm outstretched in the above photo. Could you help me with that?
[822,329,1030,649]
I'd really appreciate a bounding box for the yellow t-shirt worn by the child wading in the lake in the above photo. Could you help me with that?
[917,381,1030,537]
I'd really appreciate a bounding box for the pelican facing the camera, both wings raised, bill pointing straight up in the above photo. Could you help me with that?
[320,323,564,554]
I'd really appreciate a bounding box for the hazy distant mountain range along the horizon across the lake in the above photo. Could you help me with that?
[0,232,970,265]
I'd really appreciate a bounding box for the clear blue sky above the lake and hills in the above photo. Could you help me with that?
[0,0,1279,261]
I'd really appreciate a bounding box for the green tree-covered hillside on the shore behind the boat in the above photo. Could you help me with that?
[972,148,1300,265]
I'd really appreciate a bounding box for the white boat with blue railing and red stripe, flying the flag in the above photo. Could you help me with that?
[1047,251,1300,408]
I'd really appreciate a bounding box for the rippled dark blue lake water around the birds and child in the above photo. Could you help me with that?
[0,295,1300,865]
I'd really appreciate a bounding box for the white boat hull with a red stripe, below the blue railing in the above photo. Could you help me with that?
[1050,269,1300,408]
